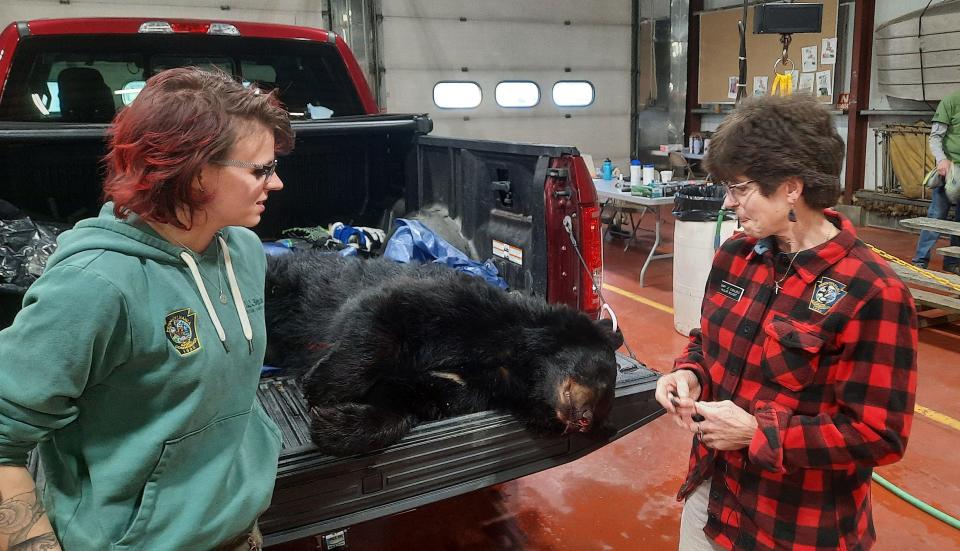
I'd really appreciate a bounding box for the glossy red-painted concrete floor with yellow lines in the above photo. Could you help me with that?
[272,216,960,551]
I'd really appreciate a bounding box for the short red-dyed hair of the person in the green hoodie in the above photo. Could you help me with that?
[103,67,293,229]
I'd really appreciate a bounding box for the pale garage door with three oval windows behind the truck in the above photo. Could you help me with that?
[381,0,631,168]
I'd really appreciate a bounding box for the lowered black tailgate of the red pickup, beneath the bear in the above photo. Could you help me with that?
[258,354,663,544]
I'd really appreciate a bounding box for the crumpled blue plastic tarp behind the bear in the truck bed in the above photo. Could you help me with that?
[383,218,507,289]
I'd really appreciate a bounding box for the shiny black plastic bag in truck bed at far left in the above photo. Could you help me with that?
[0,216,70,294]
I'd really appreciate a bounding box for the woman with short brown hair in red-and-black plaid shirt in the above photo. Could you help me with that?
[656,94,917,550]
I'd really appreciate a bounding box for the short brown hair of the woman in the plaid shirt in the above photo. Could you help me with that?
[704,94,844,208]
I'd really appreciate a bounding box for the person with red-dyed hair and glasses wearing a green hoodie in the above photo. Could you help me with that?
[0,68,293,550]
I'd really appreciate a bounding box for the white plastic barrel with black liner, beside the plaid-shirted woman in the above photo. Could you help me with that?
[673,220,737,335]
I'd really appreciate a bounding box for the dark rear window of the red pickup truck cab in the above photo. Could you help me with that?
[0,34,363,123]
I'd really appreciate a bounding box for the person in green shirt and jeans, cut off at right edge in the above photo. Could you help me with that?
[913,90,960,275]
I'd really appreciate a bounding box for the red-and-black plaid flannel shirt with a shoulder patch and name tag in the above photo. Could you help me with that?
[674,210,917,550]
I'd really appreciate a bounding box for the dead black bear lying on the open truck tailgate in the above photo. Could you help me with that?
[266,253,623,455]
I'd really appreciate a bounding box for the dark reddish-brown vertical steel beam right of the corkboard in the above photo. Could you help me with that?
[843,0,876,205]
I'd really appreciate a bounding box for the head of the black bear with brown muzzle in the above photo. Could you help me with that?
[533,315,623,434]
